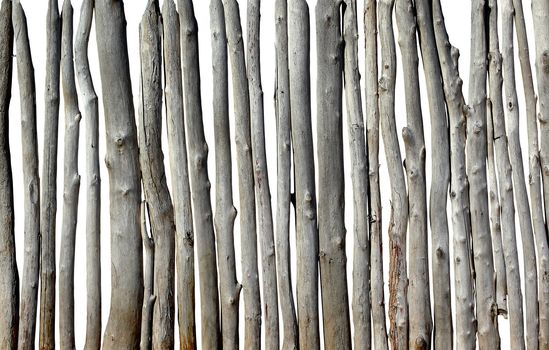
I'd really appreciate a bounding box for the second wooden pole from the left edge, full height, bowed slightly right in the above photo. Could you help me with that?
[12,0,40,350]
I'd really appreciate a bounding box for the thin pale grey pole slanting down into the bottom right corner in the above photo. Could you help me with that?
[513,0,549,349]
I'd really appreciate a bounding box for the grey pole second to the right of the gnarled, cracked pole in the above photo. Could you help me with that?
[179,0,223,349]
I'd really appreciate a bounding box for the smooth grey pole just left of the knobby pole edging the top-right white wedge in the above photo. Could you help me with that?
[415,0,453,349]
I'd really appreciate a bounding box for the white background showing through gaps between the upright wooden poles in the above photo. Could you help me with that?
[10,0,535,348]
